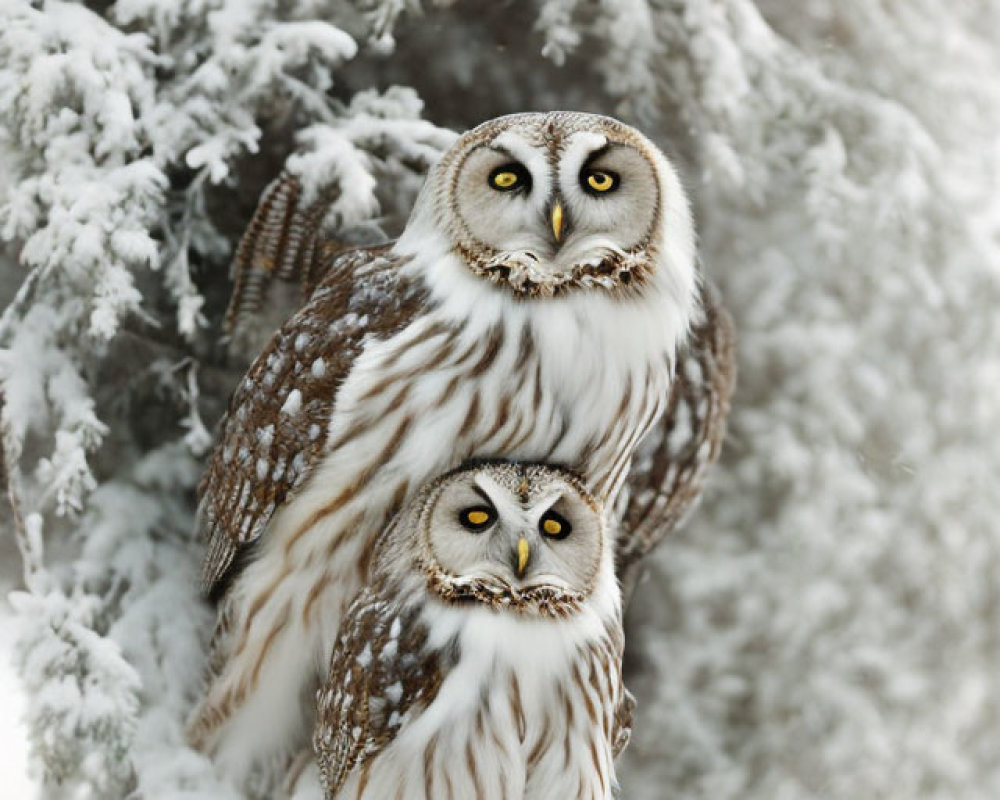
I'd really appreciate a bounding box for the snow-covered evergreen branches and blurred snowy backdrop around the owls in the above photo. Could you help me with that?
[0,0,1000,800]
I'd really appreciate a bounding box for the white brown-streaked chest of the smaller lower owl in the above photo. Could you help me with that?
[337,592,622,800]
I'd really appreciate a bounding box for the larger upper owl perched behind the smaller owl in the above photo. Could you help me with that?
[189,112,728,774]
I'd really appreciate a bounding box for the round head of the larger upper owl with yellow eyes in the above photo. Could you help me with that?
[404,112,694,296]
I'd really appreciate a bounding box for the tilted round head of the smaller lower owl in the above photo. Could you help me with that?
[378,462,614,617]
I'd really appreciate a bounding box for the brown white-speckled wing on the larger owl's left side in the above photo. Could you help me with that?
[199,223,426,594]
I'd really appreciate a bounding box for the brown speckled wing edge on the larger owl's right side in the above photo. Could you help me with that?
[617,285,736,598]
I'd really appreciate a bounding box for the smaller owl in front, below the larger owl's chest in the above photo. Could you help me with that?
[313,462,632,800]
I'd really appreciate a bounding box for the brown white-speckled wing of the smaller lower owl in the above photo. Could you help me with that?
[313,588,457,798]
